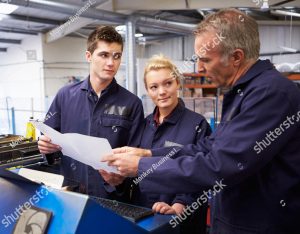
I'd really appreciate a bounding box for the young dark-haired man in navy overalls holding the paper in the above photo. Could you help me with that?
[38,26,144,199]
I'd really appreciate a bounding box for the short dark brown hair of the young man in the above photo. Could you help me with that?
[87,26,123,54]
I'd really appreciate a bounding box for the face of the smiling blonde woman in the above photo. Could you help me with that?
[146,68,179,109]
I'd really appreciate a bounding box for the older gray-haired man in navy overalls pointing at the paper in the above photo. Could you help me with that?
[106,9,300,234]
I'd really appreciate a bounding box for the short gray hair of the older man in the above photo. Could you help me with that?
[194,8,260,60]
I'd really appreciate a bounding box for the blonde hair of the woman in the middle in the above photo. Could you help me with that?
[144,54,181,89]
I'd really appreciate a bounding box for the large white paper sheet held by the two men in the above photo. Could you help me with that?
[31,121,119,174]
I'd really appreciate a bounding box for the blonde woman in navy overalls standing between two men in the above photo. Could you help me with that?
[134,55,211,233]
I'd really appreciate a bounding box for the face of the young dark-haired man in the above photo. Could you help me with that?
[86,41,122,81]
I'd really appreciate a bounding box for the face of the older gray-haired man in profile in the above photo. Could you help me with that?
[195,31,236,87]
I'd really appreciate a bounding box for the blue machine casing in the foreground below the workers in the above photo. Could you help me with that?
[0,169,179,234]
